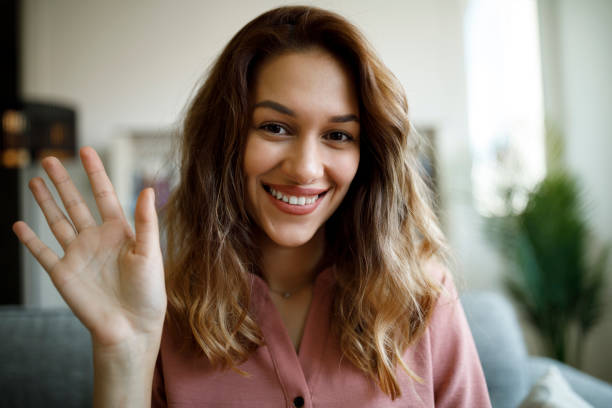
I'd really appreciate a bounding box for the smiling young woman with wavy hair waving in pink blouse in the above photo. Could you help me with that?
[14,7,490,407]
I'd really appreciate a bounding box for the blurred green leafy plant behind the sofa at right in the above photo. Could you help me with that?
[485,137,609,367]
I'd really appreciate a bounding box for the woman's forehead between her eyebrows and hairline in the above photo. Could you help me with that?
[252,48,359,114]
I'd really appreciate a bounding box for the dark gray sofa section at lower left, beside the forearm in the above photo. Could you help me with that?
[0,307,93,407]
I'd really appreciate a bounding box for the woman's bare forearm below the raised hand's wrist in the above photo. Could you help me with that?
[93,334,159,408]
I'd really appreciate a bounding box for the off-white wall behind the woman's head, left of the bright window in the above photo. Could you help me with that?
[23,0,463,145]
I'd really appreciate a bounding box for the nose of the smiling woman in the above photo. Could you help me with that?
[283,137,324,184]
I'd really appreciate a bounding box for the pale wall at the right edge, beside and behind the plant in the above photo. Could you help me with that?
[540,0,612,382]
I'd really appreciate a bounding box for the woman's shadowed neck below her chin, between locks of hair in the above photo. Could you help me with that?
[261,228,325,293]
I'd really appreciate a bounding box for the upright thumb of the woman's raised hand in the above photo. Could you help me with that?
[134,188,159,256]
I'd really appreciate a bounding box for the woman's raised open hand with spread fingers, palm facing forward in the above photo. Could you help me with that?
[13,147,166,349]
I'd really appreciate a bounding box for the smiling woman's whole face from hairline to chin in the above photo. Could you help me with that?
[244,48,360,247]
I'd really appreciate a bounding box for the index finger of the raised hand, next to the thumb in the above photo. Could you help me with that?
[80,147,127,223]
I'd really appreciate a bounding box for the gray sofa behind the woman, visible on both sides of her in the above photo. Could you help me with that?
[0,292,612,408]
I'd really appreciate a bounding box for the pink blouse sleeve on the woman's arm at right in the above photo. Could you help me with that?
[429,271,491,408]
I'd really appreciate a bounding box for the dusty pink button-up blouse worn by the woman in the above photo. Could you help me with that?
[152,269,491,408]
